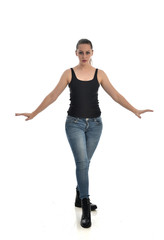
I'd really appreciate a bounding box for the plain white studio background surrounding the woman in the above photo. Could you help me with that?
[0,0,164,240]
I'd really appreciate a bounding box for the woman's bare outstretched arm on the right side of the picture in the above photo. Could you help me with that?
[99,70,153,118]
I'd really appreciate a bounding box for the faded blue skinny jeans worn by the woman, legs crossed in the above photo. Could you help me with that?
[65,115,103,199]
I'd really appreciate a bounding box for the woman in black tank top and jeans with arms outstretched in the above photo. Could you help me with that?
[16,39,152,228]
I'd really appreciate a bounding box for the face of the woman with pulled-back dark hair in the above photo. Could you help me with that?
[75,44,93,65]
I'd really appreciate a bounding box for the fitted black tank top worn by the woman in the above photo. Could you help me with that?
[67,68,101,118]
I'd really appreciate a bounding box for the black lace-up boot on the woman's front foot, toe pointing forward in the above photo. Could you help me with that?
[81,198,91,228]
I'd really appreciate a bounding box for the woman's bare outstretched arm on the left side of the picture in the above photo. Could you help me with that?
[15,70,69,121]
